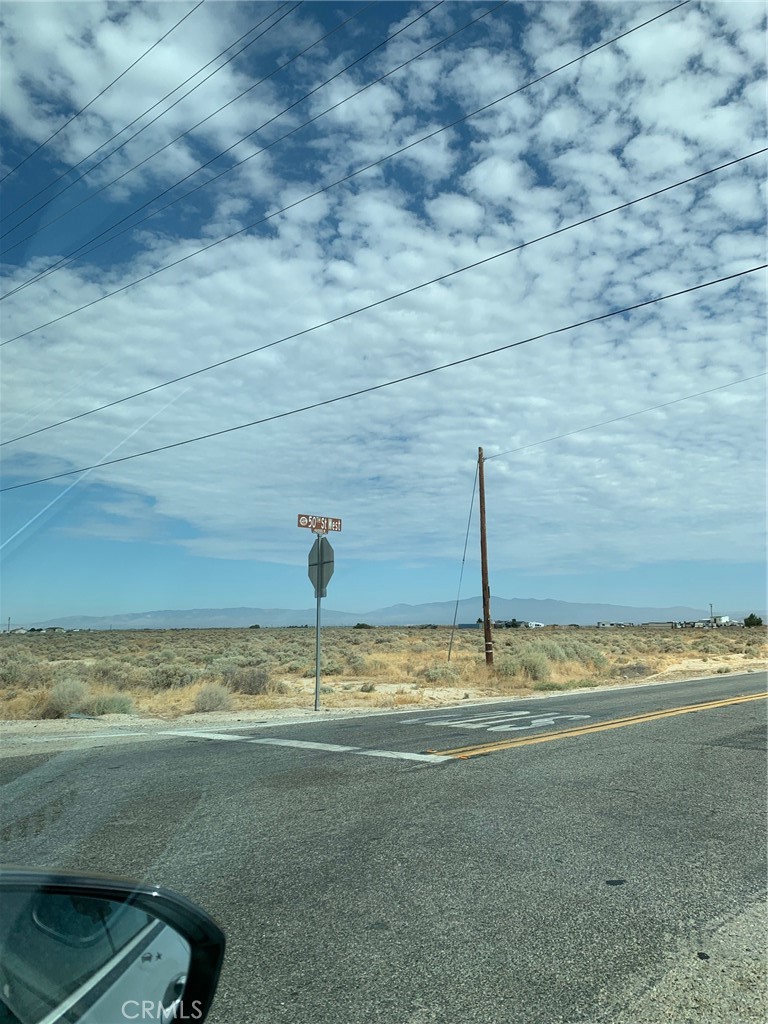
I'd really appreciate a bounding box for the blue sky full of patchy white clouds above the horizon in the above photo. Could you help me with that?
[0,0,768,626]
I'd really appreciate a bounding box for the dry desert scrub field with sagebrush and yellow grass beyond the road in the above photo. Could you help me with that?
[0,627,767,720]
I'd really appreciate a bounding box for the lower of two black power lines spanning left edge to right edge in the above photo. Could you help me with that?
[0,263,768,494]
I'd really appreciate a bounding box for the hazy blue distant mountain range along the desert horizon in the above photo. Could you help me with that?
[30,597,763,630]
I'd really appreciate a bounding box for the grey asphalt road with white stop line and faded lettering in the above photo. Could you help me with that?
[0,673,767,1024]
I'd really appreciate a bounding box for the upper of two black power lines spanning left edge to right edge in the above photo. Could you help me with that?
[0,146,768,446]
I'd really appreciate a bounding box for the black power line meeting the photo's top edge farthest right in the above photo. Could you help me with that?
[2,0,690,323]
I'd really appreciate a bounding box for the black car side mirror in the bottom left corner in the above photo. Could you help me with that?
[0,869,225,1024]
